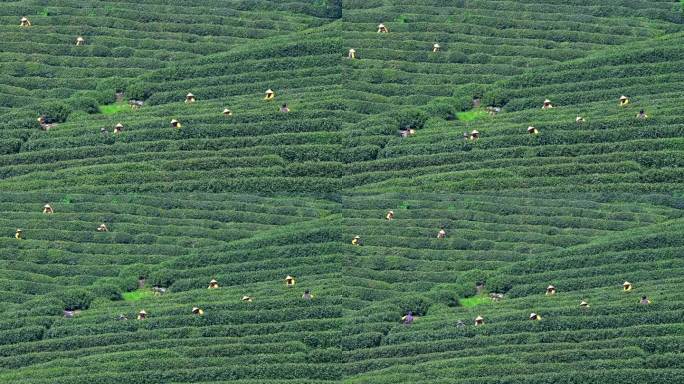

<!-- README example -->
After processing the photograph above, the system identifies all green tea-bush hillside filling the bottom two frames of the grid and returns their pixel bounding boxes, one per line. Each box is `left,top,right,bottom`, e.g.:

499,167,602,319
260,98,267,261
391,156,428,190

0,194,684,383
